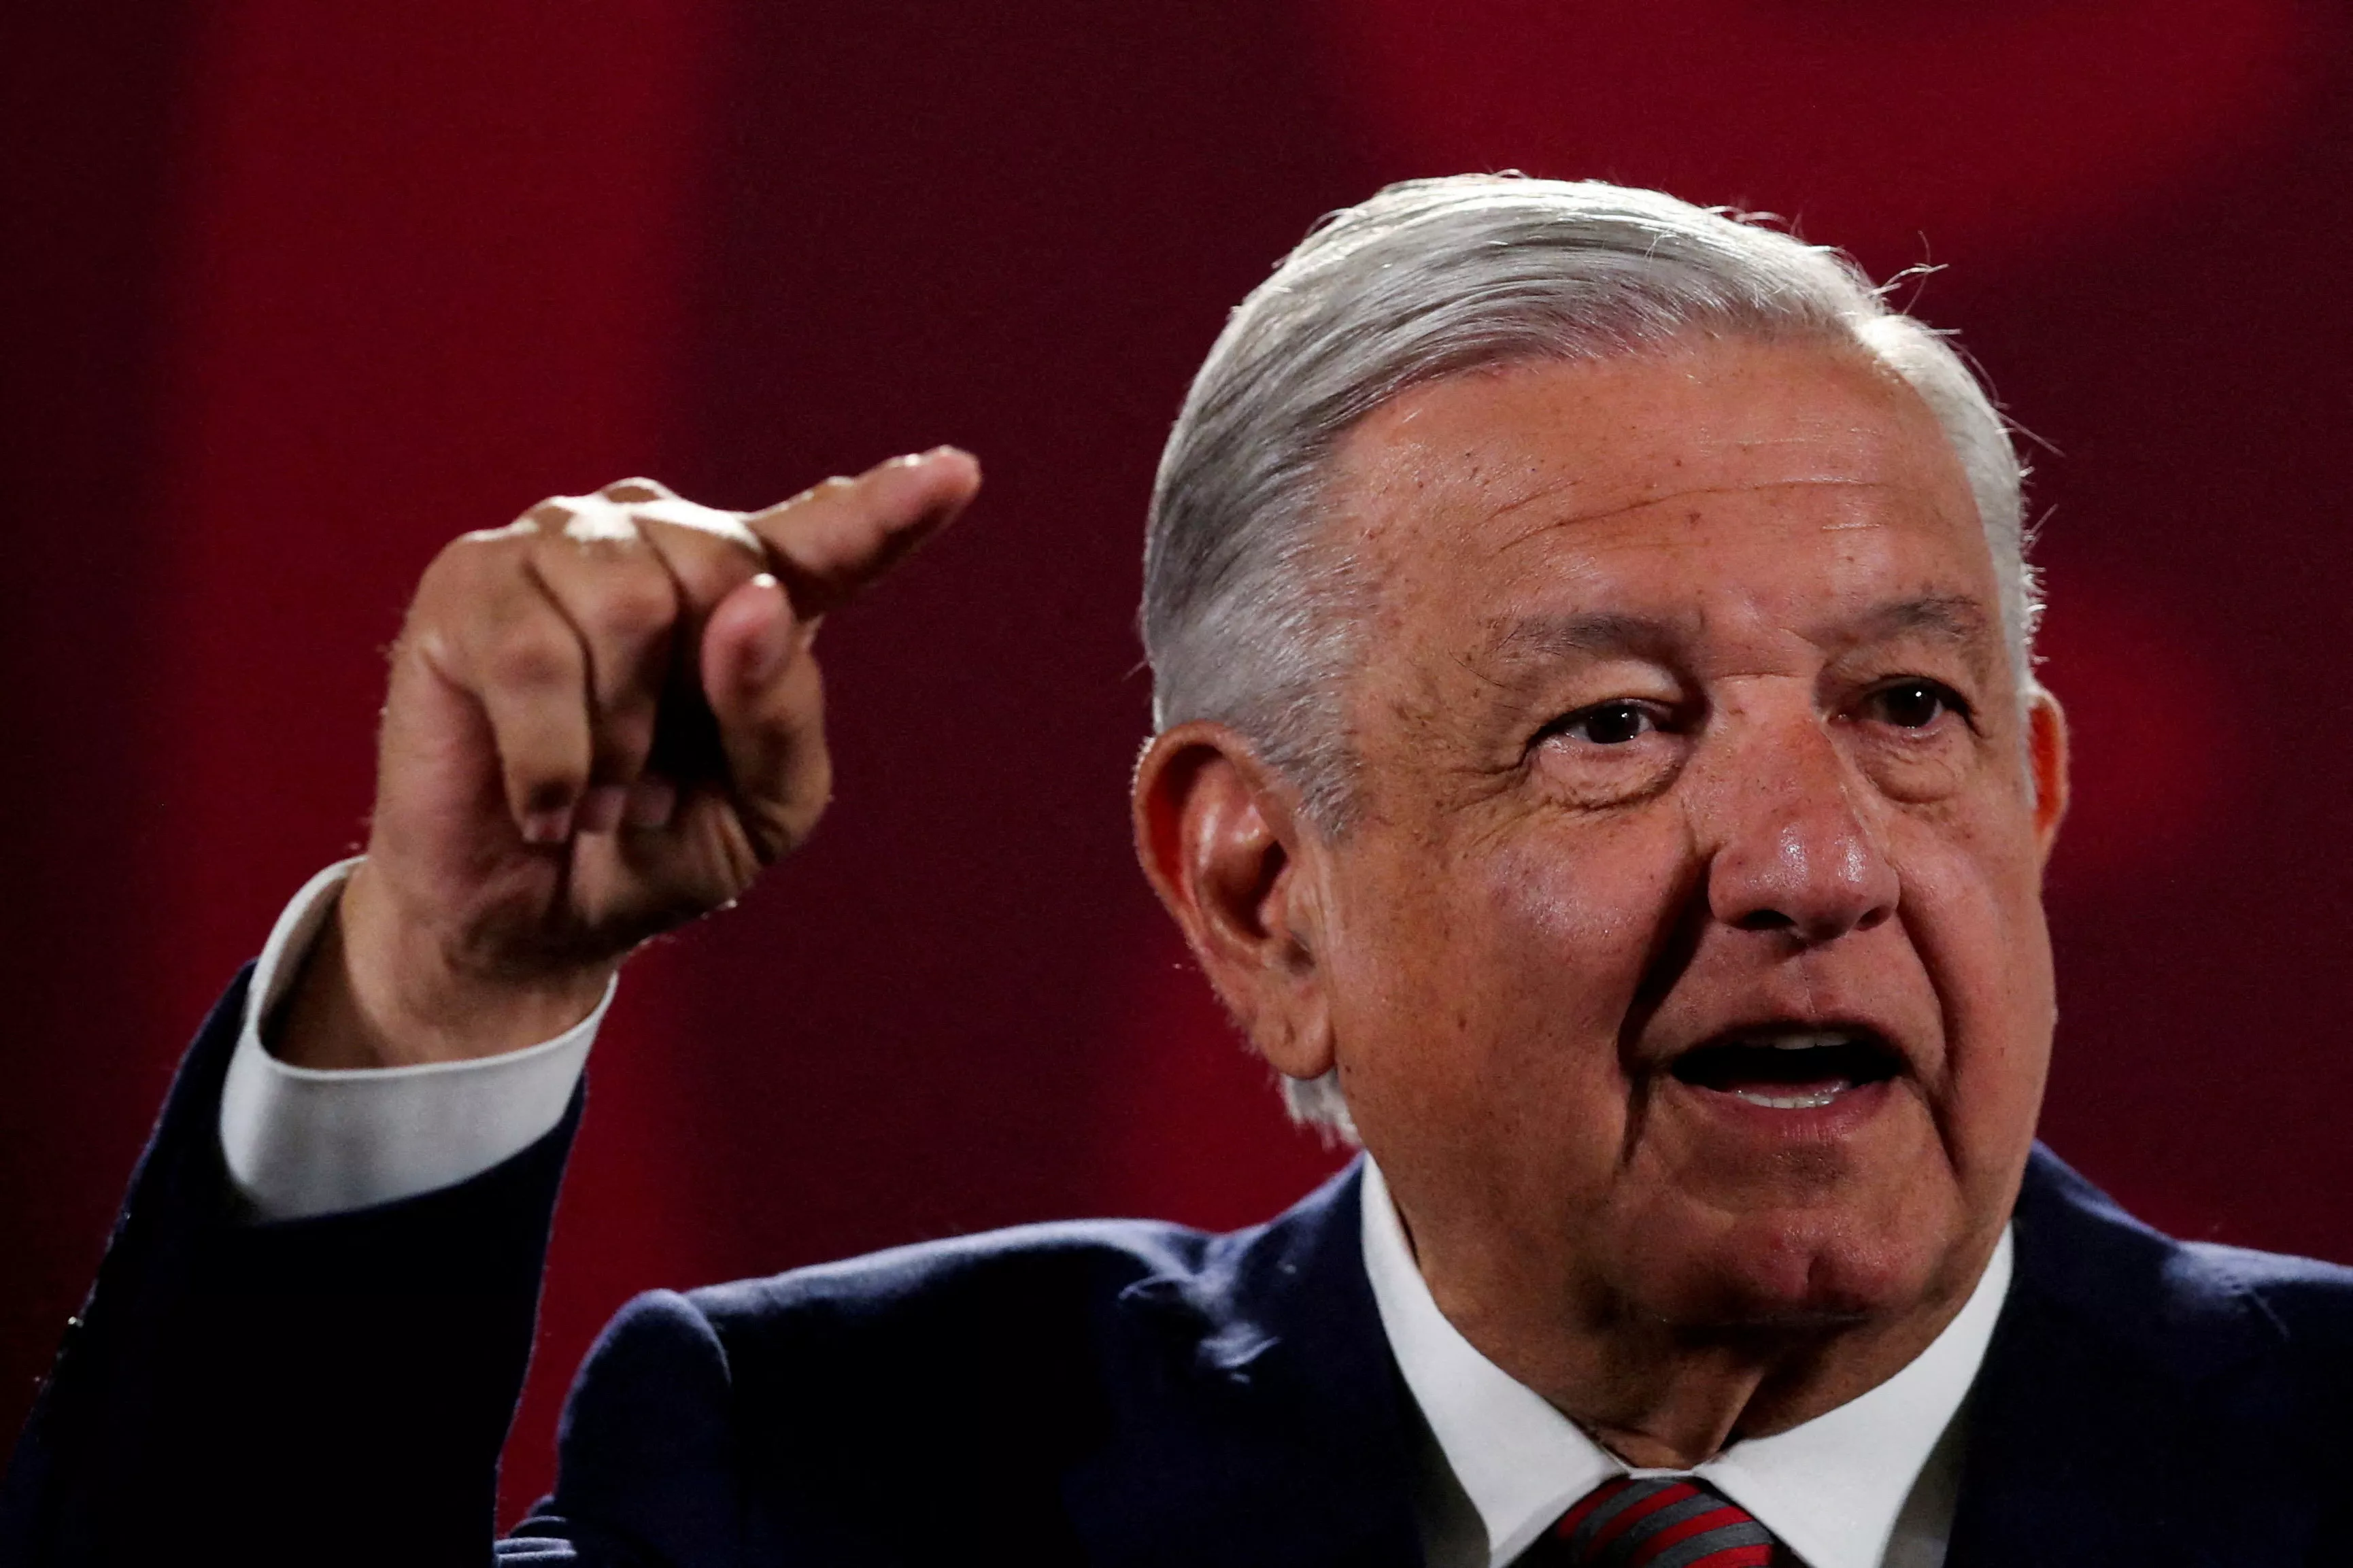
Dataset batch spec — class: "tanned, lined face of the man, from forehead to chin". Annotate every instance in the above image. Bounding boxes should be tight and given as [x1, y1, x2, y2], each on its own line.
[1313, 341, 2063, 1342]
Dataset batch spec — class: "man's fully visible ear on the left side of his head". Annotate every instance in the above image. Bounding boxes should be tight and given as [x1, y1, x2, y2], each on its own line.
[1134, 723, 1332, 1078]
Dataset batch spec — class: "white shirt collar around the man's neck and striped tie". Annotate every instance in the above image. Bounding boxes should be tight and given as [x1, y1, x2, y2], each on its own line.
[1362, 1159, 2012, 1568]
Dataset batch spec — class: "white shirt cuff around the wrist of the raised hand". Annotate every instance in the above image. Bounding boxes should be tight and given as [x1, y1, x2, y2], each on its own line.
[221, 859, 614, 1220]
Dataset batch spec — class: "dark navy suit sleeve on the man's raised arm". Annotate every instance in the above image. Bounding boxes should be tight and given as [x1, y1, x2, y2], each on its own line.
[0, 970, 581, 1566]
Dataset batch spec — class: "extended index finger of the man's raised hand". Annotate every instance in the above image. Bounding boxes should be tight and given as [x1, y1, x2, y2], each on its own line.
[743, 447, 981, 619]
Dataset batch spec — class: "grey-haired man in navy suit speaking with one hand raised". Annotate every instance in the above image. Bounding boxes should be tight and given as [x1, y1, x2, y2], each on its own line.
[7, 179, 2353, 1568]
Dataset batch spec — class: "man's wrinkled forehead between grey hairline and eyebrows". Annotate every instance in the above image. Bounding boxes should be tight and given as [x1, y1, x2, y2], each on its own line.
[1332, 341, 1995, 654]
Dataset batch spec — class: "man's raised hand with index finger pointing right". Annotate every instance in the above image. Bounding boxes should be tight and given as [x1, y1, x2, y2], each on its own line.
[273, 447, 979, 1066]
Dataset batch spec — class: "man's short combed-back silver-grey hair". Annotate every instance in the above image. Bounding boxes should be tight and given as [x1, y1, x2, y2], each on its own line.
[1141, 174, 2040, 1135]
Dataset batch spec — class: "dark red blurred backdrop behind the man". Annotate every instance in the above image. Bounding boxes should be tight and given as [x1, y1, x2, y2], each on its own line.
[0, 0, 2353, 1500]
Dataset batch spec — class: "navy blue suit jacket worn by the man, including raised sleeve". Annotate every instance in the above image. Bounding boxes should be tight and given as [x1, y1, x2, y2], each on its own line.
[0, 960, 2353, 1568]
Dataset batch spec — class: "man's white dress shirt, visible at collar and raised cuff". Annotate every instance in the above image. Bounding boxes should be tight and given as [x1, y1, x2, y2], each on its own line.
[221, 862, 2012, 1568]
